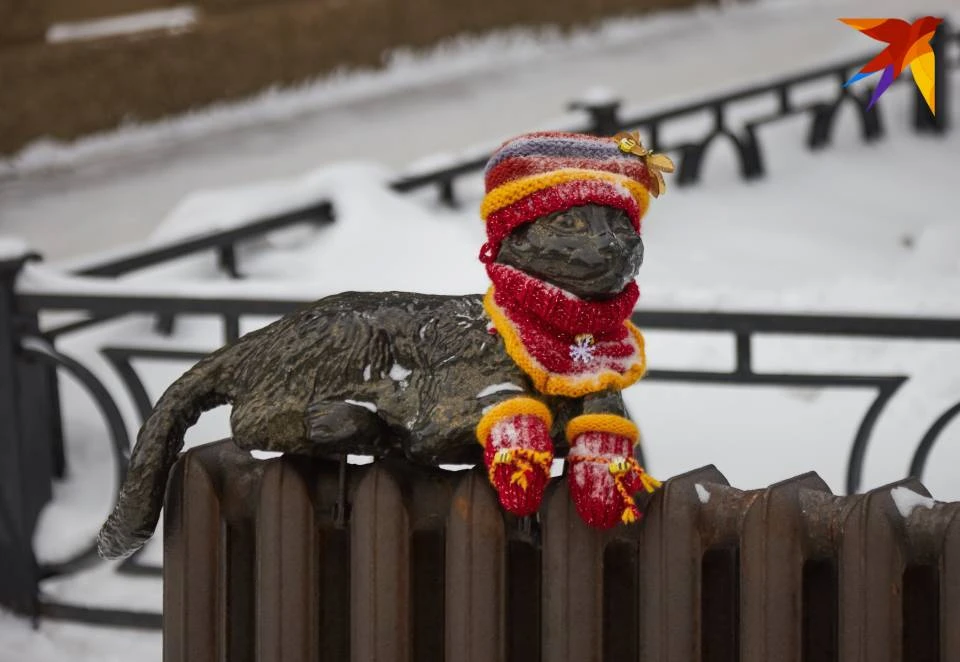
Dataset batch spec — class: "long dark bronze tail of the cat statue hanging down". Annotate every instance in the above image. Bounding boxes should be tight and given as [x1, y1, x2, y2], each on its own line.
[97, 348, 231, 559]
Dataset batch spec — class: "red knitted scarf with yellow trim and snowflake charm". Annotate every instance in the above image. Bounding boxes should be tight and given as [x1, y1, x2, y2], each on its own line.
[483, 263, 646, 398]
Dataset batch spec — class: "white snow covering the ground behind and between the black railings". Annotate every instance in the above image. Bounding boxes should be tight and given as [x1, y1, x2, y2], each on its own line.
[0, 0, 960, 662]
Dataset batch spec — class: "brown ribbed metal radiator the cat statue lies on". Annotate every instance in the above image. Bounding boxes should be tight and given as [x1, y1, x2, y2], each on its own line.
[164, 441, 960, 662]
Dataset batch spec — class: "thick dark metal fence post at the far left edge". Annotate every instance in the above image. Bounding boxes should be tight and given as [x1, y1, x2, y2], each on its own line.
[0, 248, 42, 617]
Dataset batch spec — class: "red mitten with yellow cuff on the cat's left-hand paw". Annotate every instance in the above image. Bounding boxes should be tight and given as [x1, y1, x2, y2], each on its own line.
[477, 397, 553, 517]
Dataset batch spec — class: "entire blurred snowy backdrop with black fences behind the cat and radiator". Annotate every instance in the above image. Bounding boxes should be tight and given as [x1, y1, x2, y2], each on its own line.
[0, 0, 960, 662]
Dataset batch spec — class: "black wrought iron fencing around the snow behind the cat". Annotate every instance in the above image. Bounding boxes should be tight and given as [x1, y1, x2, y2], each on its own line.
[0, 19, 960, 627]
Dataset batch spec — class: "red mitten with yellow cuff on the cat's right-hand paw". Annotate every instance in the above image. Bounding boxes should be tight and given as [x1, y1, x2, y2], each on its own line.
[567, 414, 660, 529]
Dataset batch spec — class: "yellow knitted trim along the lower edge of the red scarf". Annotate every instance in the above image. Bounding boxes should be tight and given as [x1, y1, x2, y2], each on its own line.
[483, 286, 647, 398]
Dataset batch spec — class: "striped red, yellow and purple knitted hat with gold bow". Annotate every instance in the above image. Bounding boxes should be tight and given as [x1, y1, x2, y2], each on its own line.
[480, 131, 673, 262]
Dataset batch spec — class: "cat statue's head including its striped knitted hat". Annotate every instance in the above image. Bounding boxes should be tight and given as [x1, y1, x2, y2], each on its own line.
[480, 132, 673, 299]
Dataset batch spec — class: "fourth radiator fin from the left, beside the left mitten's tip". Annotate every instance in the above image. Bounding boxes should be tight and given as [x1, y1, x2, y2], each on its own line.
[444, 471, 510, 662]
